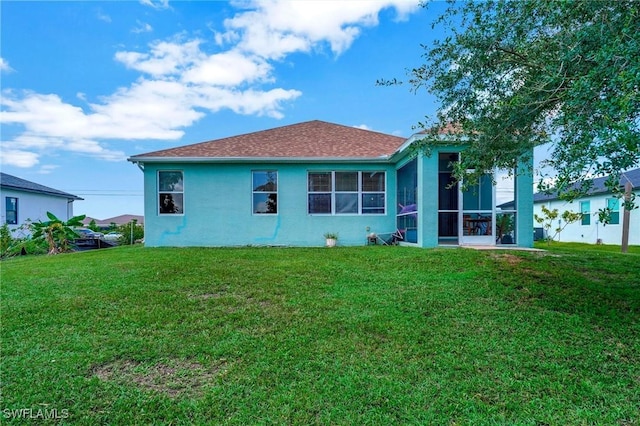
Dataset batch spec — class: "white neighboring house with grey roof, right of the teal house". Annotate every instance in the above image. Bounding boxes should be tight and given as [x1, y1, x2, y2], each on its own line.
[533, 169, 640, 245]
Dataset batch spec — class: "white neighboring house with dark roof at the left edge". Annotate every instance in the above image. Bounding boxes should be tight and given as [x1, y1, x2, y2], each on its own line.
[0, 173, 82, 235]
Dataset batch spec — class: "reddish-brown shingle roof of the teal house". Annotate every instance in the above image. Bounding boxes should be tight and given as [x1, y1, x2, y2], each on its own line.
[129, 120, 405, 162]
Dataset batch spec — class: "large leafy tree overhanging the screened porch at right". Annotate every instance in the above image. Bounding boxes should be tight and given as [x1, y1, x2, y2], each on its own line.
[385, 0, 640, 208]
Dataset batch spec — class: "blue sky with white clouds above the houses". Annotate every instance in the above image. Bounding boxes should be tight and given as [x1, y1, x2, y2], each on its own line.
[0, 0, 536, 219]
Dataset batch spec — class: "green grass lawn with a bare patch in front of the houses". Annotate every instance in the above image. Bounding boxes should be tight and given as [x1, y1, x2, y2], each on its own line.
[0, 245, 640, 426]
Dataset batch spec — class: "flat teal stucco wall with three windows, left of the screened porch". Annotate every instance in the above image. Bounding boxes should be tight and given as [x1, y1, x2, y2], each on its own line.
[144, 163, 396, 247]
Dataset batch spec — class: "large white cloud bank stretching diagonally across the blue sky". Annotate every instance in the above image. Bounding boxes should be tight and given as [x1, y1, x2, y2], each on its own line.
[0, 0, 418, 167]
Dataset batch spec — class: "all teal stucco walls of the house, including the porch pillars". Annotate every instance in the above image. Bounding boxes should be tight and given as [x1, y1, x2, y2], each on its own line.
[144, 145, 533, 247]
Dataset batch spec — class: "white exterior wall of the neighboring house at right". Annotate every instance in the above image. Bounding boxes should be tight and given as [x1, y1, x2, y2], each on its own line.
[534, 191, 640, 245]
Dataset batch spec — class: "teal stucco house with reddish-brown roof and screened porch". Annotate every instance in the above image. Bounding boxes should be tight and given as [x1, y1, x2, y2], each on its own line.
[129, 121, 533, 247]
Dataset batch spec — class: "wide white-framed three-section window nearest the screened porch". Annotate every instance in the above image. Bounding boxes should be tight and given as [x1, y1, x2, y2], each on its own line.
[307, 171, 386, 215]
